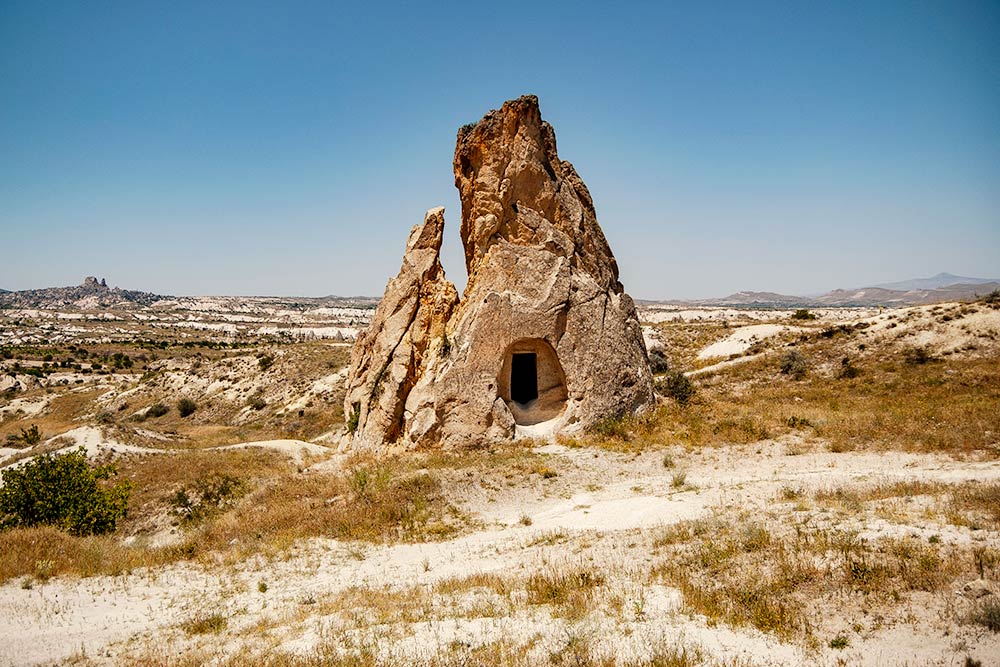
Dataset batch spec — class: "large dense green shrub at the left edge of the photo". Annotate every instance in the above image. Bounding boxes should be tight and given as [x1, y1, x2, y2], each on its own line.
[0, 447, 132, 535]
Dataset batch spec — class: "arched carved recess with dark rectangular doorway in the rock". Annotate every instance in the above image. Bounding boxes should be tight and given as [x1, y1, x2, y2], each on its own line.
[497, 338, 567, 426]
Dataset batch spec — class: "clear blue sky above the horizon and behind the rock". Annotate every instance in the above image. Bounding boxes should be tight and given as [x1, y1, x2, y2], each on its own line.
[0, 0, 1000, 298]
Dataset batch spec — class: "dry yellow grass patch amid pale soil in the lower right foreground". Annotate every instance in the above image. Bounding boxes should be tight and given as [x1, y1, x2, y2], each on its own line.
[653, 518, 973, 640]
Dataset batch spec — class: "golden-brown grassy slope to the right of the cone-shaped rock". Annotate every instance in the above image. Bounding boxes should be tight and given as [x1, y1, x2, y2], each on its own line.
[580, 358, 1000, 458]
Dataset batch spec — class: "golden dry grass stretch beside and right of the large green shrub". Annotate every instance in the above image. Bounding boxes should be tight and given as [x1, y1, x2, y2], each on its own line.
[0, 450, 462, 581]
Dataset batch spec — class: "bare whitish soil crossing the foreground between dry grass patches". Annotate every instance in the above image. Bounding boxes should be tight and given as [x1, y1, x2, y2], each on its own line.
[0, 439, 1000, 665]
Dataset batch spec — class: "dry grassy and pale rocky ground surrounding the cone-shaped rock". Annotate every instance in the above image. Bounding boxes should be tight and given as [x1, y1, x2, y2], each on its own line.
[0, 300, 1000, 666]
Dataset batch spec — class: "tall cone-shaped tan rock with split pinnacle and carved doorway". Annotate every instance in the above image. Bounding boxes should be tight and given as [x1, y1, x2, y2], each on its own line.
[345, 96, 654, 447]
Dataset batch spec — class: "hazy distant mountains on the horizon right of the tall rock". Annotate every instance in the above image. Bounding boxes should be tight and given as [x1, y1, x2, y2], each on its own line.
[640, 273, 1000, 308]
